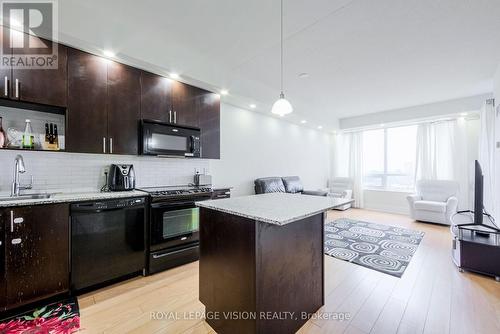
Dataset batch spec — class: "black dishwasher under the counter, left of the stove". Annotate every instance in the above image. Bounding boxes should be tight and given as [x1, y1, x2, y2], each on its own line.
[71, 198, 146, 291]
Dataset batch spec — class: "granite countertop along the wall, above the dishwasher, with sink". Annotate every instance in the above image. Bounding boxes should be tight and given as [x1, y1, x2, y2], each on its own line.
[0, 190, 148, 208]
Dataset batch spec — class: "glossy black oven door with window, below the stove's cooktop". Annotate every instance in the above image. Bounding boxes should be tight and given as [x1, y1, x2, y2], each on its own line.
[150, 201, 200, 251]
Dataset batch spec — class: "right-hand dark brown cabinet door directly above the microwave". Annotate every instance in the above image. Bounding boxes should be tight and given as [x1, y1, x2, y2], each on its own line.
[173, 82, 200, 127]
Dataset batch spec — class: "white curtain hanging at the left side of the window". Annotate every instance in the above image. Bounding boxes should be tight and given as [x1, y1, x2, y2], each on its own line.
[333, 132, 364, 208]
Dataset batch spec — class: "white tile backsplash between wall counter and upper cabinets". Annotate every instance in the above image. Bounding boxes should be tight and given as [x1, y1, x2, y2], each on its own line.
[0, 149, 209, 194]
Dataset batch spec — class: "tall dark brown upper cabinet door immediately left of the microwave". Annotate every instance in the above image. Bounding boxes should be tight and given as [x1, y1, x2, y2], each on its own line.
[106, 61, 141, 154]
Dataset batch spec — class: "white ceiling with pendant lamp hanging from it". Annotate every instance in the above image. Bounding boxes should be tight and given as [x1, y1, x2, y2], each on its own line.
[59, 0, 500, 128]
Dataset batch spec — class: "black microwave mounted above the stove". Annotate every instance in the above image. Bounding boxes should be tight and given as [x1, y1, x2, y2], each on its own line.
[141, 120, 201, 158]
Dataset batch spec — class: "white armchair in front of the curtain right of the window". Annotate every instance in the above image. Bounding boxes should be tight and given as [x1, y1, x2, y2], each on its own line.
[407, 180, 459, 225]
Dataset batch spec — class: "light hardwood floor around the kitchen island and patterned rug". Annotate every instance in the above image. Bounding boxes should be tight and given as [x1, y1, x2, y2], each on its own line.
[79, 209, 500, 334]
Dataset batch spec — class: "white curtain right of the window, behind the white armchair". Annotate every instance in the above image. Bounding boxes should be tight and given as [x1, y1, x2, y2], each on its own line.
[415, 119, 473, 209]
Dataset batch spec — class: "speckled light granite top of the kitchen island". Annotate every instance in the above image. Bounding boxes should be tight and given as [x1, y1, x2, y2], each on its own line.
[196, 193, 352, 225]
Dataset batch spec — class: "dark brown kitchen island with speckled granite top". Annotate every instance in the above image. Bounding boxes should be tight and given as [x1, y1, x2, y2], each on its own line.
[197, 193, 351, 333]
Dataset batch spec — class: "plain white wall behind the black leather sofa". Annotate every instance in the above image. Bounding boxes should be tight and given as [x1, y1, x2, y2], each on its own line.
[210, 104, 330, 196]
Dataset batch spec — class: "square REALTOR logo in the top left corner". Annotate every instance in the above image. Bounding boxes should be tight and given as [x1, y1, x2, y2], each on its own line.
[0, 0, 58, 69]
